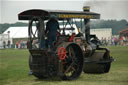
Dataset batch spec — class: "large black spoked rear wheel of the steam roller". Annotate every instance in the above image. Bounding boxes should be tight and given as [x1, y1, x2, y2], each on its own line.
[61, 45, 83, 80]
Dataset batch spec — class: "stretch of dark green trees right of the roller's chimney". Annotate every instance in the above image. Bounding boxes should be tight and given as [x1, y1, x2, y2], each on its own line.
[91, 19, 128, 35]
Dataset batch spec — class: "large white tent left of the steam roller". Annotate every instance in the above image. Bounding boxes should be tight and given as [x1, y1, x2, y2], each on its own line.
[2, 26, 35, 47]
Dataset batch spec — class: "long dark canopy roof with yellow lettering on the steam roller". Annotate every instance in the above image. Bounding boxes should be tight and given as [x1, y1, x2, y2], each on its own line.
[18, 9, 100, 20]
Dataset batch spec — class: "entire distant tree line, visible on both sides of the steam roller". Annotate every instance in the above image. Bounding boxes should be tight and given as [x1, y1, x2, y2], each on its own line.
[0, 19, 128, 35]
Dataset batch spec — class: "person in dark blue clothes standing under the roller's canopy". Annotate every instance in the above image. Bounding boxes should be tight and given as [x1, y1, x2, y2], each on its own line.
[45, 17, 60, 48]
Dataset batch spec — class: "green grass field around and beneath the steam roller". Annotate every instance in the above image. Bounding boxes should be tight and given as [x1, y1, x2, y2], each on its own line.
[0, 46, 128, 85]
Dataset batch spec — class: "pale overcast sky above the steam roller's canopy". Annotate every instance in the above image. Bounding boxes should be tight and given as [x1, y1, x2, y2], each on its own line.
[0, 0, 128, 23]
